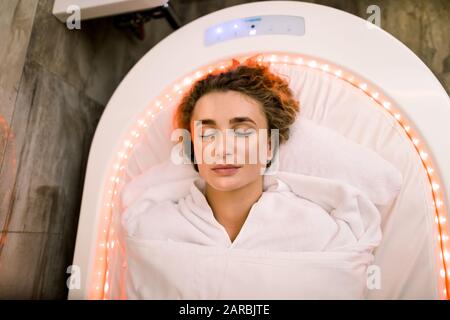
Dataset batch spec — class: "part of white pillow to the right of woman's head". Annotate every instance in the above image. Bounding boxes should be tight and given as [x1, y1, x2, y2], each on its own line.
[279, 115, 402, 206]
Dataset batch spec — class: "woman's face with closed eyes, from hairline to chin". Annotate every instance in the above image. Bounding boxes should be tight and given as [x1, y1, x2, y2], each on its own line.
[191, 90, 271, 191]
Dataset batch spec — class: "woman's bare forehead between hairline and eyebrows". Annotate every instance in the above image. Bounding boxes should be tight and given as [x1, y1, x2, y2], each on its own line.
[191, 90, 266, 126]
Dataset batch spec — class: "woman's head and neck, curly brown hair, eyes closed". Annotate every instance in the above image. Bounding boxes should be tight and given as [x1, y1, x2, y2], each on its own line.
[171, 59, 299, 241]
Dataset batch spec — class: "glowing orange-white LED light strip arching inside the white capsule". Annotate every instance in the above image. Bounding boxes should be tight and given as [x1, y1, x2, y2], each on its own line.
[89, 53, 450, 299]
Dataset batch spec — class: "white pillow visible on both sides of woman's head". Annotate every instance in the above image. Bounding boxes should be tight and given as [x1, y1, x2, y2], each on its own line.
[122, 116, 402, 207]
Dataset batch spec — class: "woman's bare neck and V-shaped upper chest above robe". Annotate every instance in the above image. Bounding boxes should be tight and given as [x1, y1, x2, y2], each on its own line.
[205, 176, 263, 241]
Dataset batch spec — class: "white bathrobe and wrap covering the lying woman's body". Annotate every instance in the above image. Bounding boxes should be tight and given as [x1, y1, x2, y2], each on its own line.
[122, 172, 381, 299]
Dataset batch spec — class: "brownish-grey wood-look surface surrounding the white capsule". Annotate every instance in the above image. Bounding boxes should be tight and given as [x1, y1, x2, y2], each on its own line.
[0, 0, 450, 299]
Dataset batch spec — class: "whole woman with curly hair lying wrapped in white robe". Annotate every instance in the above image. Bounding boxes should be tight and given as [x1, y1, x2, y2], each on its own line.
[122, 59, 381, 299]
